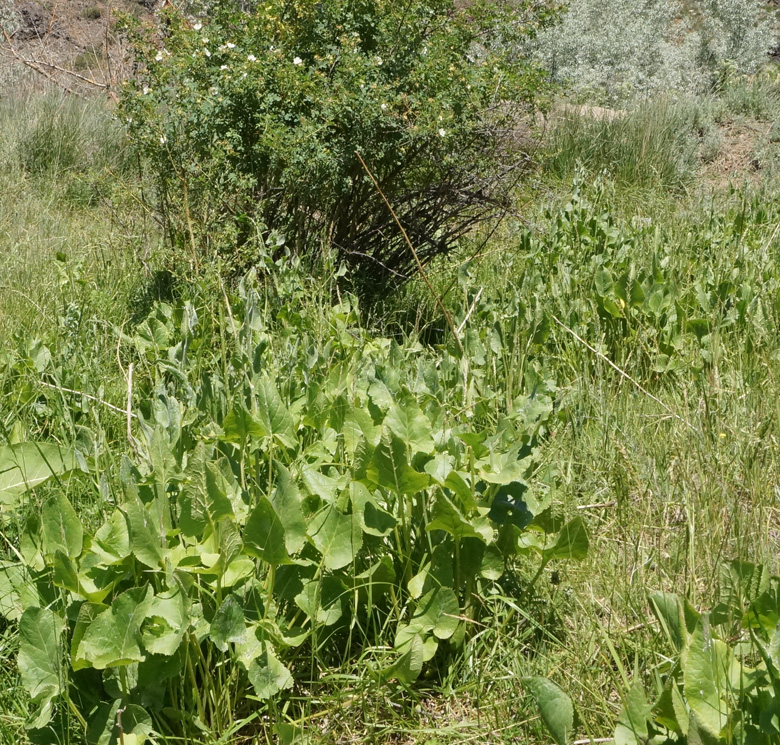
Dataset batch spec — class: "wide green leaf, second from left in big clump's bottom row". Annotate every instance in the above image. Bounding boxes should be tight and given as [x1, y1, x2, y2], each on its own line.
[78, 587, 154, 670]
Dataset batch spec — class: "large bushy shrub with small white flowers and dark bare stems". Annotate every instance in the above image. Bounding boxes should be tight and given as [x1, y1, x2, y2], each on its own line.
[124, 0, 547, 281]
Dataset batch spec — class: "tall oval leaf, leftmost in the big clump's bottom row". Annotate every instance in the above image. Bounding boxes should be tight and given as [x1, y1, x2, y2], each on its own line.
[16, 608, 64, 728]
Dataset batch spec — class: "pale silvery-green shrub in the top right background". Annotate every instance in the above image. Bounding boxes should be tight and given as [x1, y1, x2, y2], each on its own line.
[534, 0, 774, 105]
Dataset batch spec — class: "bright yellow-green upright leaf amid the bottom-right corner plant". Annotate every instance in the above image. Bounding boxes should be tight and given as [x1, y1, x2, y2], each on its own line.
[681, 614, 728, 738]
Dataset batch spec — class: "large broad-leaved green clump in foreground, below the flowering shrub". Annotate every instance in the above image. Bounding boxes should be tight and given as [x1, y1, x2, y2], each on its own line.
[0, 271, 588, 742]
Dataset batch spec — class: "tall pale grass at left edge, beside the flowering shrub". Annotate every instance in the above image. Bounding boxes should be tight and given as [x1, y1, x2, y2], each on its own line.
[0, 92, 154, 341]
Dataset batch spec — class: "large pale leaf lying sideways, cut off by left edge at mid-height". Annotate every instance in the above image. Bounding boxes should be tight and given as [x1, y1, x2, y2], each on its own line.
[0, 442, 78, 512]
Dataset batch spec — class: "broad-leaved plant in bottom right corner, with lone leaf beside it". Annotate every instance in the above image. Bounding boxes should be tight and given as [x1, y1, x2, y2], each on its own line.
[527, 560, 780, 745]
